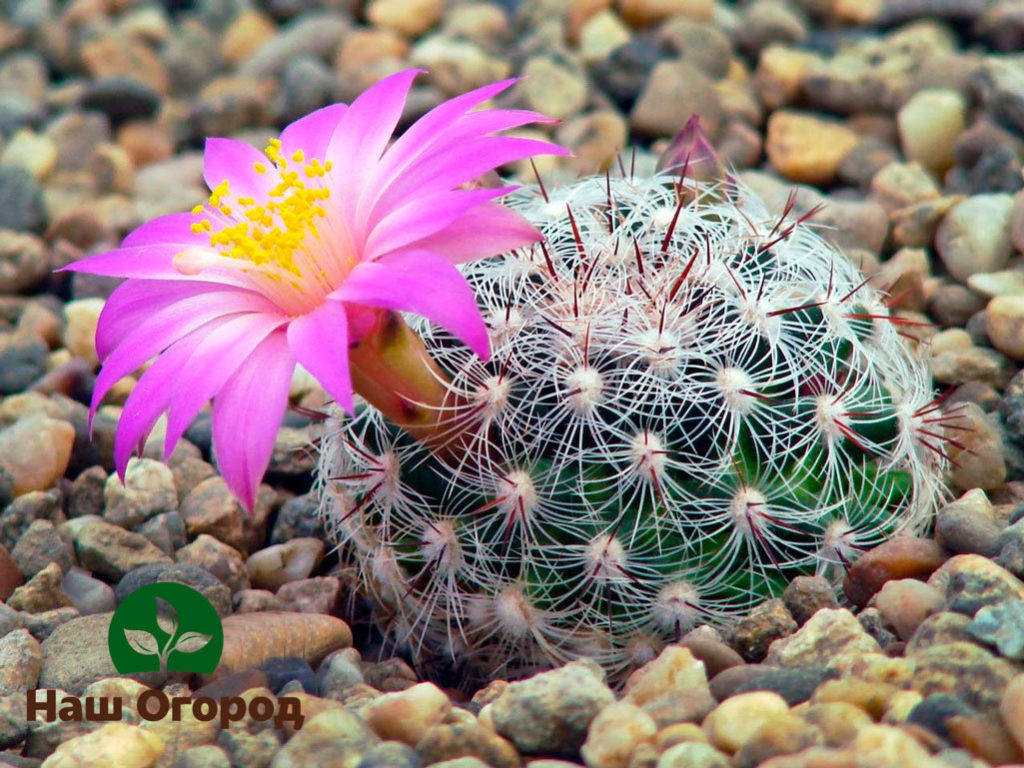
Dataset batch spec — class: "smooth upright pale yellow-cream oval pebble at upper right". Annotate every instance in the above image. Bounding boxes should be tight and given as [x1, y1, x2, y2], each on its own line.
[896, 88, 967, 174]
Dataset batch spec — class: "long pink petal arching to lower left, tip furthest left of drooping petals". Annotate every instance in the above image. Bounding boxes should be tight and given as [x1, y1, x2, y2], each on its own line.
[90, 291, 275, 416]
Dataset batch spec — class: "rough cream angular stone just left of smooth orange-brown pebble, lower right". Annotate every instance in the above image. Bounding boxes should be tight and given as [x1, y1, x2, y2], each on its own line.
[765, 608, 880, 667]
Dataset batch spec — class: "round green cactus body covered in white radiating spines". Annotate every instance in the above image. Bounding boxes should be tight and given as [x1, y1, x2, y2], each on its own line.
[318, 162, 955, 674]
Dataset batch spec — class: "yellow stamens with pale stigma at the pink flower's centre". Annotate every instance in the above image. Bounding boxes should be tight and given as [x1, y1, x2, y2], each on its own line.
[182, 138, 338, 310]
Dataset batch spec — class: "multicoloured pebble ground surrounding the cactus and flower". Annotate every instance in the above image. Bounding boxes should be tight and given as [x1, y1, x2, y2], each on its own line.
[0, 0, 1024, 768]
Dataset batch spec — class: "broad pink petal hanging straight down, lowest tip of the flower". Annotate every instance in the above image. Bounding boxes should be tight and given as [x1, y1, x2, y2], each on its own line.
[212, 331, 295, 512]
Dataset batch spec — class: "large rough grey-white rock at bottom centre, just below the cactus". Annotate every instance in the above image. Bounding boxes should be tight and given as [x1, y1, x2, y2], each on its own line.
[490, 662, 614, 755]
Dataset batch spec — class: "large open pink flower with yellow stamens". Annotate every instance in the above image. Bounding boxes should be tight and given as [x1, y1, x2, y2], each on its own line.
[69, 71, 565, 510]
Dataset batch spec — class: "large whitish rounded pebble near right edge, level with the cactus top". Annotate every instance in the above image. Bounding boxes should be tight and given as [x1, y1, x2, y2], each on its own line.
[935, 194, 1013, 283]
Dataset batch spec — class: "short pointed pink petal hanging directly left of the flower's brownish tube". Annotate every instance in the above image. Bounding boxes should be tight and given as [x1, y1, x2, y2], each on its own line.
[288, 301, 352, 413]
